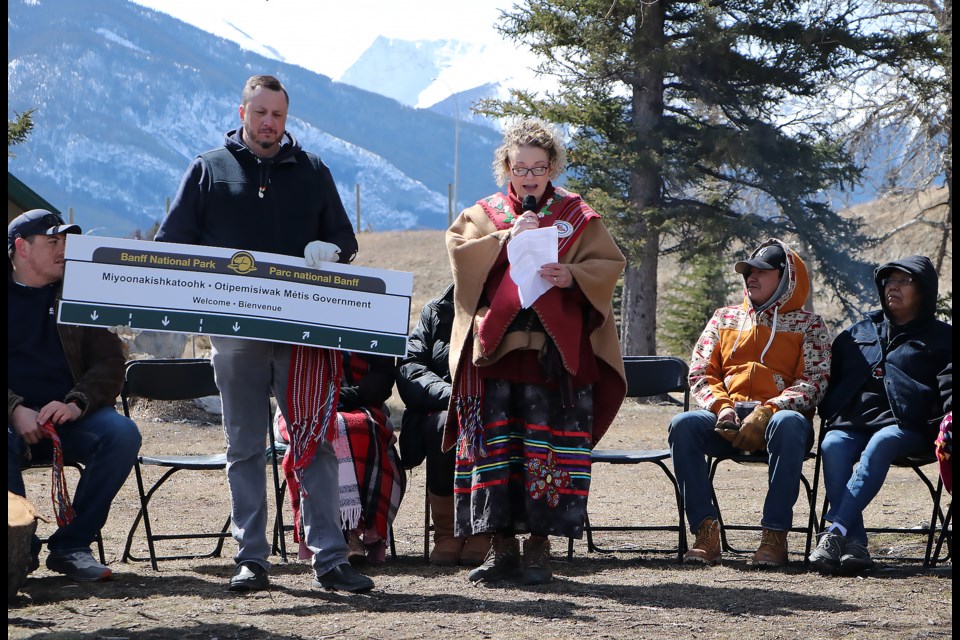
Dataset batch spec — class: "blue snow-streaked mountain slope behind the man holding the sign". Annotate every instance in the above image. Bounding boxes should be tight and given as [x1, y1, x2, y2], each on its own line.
[7, 0, 499, 235]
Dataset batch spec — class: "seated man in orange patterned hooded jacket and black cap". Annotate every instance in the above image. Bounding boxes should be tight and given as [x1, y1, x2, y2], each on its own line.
[668, 239, 830, 567]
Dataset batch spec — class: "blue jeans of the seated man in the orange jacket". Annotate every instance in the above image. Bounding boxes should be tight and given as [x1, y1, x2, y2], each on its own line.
[667, 410, 813, 533]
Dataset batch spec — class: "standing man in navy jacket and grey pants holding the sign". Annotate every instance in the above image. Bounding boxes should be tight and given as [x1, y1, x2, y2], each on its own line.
[156, 76, 373, 592]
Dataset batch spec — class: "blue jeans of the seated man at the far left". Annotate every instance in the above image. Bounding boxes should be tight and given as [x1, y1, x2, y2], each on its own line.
[7, 407, 140, 553]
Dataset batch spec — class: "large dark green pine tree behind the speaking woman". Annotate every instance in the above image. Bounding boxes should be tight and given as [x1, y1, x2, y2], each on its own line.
[480, 0, 924, 354]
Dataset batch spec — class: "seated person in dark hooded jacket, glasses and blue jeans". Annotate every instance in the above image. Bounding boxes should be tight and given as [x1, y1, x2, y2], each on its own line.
[810, 256, 953, 573]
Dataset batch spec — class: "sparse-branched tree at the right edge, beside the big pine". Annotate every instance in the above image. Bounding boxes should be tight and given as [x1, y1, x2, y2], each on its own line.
[825, 0, 953, 271]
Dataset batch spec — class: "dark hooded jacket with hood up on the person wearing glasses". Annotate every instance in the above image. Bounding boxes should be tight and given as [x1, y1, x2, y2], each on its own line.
[820, 256, 953, 446]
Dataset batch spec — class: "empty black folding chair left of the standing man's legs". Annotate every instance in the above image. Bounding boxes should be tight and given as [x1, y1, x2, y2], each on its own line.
[120, 358, 287, 571]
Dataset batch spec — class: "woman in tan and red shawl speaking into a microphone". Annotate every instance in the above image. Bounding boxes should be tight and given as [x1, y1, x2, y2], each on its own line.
[443, 118, 626, 585]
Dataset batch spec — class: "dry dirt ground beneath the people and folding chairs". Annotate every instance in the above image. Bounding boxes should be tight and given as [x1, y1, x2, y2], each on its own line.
[7, 396, 953, 640]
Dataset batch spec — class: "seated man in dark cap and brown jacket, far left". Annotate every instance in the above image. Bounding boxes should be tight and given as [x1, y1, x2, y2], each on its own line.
[7, 209, 140, 582]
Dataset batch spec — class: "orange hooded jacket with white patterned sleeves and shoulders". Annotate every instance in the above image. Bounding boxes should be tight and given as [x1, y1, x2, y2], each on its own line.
[689, 238, 831, 418]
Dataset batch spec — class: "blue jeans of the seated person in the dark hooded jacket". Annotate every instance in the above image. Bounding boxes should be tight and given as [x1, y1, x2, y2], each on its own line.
[820, 425, 933, 546]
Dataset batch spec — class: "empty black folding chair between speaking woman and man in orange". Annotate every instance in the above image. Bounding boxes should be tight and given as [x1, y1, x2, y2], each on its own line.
[567, 356, 690, 562]
